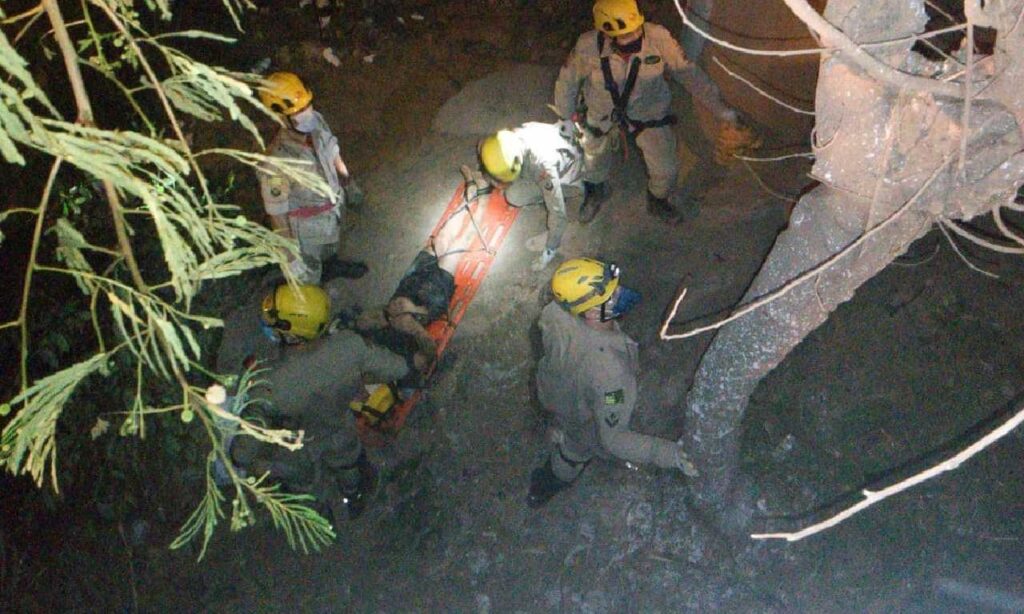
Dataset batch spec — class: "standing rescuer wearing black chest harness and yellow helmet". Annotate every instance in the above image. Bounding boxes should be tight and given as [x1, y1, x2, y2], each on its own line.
[555, 0, 736, 221]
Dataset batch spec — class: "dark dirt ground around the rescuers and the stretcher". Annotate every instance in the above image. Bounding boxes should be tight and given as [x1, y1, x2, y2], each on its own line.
[12, 2, 1024, 613]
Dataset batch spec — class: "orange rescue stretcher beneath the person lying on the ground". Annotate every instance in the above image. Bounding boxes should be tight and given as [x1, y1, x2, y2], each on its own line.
[350, 181, 519, 447]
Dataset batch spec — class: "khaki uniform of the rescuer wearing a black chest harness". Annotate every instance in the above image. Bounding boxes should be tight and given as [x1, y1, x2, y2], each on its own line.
[555, 23, 732, 199]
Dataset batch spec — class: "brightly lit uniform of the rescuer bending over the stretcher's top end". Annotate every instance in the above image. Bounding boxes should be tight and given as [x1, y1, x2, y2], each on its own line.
[505, 122, 583, 251]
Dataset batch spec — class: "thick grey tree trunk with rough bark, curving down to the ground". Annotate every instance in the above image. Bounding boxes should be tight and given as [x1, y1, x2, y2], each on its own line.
[685, 0, 1024, 511]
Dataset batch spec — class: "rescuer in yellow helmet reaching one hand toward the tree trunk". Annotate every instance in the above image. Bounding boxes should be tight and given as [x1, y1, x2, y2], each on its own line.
[526, 258, 694, 508]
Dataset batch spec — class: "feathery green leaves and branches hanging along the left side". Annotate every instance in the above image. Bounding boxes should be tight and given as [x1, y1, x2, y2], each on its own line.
[0, 0, 334, 558]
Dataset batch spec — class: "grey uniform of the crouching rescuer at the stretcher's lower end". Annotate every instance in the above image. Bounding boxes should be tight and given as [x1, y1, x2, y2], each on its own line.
[232, 331, 408, 493]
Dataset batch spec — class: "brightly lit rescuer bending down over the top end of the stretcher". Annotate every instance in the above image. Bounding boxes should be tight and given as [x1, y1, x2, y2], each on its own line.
[478, 122, 583, 271]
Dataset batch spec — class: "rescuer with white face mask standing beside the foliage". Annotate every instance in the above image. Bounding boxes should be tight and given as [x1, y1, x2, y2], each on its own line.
[258, 73, 367, 283]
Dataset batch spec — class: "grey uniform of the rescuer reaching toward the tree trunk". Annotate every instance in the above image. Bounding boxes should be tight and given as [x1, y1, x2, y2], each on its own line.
[537, 302, 679, 482]
